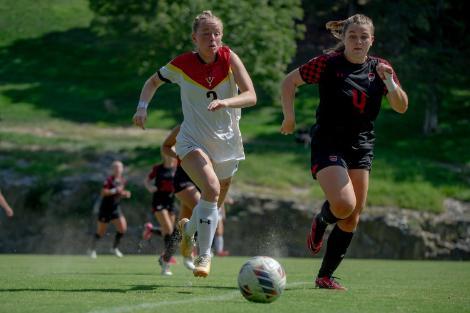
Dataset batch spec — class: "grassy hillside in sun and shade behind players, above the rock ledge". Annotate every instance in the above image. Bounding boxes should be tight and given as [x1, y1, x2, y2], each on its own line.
[0, 0, 470, 212]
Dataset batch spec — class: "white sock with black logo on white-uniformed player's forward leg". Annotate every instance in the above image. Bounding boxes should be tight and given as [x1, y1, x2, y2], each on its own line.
[191, 200, 219, 255]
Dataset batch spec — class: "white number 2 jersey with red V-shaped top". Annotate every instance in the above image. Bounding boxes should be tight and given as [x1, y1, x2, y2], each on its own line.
[159, 46, 245, 163]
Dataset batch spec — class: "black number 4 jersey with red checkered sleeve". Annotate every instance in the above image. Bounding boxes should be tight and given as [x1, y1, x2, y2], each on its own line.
[299, 53, 398, 148]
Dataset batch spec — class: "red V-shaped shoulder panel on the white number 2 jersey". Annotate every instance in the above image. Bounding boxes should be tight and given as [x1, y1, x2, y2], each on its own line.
[170, 46, 230, 90]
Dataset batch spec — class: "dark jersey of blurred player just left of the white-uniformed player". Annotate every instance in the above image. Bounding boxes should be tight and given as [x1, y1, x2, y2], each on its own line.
[148, 163, 175, 205]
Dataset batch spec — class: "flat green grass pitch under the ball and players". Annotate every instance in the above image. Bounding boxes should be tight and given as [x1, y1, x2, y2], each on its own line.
[0, 255, 470, 313]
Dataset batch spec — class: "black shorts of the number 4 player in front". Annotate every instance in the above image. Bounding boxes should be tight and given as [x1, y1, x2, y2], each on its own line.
[310, 140, 374, 179]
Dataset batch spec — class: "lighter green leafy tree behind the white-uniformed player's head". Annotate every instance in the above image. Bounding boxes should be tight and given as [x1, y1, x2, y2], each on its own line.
[90, 0, 304, 98]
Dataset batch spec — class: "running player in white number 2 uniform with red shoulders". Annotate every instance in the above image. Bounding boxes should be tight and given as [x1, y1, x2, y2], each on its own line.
[133, 11, 256, 277]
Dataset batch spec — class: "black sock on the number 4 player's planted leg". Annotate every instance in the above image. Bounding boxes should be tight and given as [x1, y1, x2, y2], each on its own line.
[318, 225, 354, 277]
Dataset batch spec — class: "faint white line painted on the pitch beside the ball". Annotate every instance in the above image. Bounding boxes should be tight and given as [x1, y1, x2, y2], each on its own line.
[88, 282, 312, 313]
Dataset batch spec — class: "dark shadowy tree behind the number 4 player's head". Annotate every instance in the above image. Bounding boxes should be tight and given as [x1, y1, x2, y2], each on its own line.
[299, 0, 470, 135]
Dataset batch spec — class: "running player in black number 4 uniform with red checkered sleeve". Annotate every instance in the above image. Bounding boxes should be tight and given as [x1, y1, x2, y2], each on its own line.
[281, 14, 408, 290]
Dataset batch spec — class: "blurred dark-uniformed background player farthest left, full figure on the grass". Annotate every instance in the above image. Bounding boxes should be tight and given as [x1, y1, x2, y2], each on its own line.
[90, 161, 131, 259]
